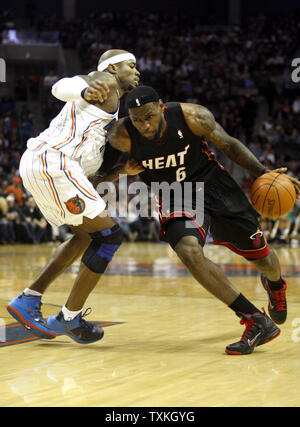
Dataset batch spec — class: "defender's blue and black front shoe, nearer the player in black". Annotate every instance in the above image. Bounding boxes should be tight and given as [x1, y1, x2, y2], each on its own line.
[47, 309, 104, 344]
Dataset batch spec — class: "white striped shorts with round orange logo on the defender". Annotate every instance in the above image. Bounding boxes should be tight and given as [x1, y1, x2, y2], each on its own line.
[19, 149, 106, 226]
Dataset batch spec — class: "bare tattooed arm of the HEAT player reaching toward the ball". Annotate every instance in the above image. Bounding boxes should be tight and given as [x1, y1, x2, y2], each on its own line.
[181, 104, 270, 177]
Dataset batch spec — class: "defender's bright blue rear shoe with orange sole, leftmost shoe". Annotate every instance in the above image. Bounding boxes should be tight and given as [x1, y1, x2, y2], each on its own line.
[6, 293, 56, 340]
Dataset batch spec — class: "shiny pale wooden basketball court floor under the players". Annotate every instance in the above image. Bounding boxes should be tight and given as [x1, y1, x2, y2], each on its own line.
[0, 243, 300, 407]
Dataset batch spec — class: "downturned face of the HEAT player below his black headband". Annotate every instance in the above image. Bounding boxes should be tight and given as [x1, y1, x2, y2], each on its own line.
[129, 101, 166, 141]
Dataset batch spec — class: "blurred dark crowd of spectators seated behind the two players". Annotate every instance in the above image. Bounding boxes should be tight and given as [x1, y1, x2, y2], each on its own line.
[0, 11, 300, 244]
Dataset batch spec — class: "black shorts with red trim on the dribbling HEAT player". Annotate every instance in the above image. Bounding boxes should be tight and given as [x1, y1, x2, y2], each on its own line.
[161, 170, 270, 259]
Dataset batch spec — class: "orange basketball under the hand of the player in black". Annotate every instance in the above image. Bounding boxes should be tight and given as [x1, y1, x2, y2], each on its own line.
[250, 172, 296, 219]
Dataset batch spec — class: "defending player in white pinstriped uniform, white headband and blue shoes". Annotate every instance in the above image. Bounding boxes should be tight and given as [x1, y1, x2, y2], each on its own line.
[7, 50, 140, 344]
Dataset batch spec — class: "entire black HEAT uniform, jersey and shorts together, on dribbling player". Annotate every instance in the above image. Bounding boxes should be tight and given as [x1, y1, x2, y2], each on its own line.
[125, 102, 269, 259]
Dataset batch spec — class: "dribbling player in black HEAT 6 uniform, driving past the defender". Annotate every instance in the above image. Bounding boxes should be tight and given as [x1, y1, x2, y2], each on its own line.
[106, 86, 300, 354]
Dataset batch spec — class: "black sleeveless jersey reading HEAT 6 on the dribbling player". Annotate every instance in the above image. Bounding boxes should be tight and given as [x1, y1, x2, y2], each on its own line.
[125, 102, 221, 184]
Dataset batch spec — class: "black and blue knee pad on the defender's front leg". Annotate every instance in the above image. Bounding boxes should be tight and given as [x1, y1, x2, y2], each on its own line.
[82, 225, 123, 274]
